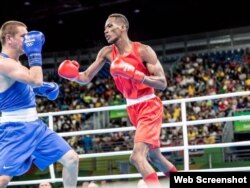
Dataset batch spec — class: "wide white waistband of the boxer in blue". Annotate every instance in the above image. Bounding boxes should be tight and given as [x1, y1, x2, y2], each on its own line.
[1, 108, 38, 123]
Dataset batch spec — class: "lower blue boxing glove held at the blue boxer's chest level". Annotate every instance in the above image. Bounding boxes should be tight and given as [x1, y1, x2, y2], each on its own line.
[33, 82, 59, 101]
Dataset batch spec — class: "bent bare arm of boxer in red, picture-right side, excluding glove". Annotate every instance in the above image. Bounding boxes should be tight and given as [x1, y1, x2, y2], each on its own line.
[139, 45, 167, 90]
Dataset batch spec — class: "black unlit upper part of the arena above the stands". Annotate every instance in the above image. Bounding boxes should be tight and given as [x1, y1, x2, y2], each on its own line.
[0, 0, 250, 51]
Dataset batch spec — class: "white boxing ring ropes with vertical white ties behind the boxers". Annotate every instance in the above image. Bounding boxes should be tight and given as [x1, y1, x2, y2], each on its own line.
[4, 91, 250, 186]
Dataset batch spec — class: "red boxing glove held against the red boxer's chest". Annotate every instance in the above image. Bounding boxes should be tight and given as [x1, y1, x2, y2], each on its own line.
[110, 58, 145, 82]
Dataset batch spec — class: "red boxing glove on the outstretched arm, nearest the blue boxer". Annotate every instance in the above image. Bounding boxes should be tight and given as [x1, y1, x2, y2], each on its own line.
[58, 60, 80, 81]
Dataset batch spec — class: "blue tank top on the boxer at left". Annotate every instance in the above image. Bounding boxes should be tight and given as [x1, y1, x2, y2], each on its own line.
[0, 53, 36, 112]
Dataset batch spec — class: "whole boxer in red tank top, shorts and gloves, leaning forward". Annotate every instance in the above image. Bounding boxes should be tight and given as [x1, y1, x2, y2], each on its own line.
[58, 14, 176, 188]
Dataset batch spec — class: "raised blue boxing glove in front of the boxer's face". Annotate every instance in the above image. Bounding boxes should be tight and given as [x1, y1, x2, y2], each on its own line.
[23, 31, 45, 67]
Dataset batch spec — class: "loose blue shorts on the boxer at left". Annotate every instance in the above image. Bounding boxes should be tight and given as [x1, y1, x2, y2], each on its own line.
[0, 119, 71, 176]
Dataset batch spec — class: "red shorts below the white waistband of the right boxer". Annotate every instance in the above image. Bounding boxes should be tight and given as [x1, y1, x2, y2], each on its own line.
[127, 97, 163, 149]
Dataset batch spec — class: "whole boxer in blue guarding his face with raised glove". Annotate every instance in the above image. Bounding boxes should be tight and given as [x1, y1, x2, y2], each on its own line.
[0, 21, 79, 188]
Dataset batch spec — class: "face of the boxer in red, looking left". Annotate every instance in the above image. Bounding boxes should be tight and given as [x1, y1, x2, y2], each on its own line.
[104, 17, 124, 44]
